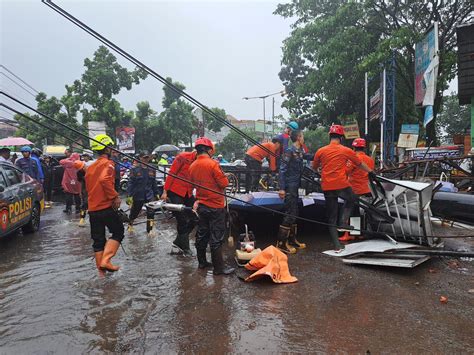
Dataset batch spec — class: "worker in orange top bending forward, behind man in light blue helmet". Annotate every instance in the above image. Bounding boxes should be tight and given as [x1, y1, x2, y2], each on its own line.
[245, 136, 282, 191]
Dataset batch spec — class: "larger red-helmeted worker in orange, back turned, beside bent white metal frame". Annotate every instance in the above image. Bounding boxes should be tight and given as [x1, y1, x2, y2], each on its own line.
[313, 125, 373, 252]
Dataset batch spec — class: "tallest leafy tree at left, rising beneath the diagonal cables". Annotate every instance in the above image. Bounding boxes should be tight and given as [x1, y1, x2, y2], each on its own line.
[72, 46, 147, 134]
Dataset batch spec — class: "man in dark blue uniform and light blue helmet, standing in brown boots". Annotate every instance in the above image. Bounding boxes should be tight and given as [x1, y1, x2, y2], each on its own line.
[277, 130, 313, 254]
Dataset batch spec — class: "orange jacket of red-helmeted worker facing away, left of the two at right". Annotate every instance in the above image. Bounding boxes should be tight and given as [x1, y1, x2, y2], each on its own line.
[313, 141, 362, 191]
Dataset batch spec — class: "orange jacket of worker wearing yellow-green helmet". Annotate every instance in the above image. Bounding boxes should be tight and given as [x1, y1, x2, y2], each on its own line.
[86, 157, 118, 211]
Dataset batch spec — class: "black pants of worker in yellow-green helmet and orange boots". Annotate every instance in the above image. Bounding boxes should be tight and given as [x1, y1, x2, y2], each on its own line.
[89, 207, 124, 252]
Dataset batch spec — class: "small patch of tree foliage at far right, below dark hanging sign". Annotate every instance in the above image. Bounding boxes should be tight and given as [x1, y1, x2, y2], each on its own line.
[436, 94, 471, 141]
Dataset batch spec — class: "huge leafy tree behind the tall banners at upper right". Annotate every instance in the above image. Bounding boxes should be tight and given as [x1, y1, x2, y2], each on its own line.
[275, 0, 473, 143]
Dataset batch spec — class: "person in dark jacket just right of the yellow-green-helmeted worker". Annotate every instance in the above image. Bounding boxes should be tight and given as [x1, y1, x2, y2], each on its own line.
[127, 152, 160, 237]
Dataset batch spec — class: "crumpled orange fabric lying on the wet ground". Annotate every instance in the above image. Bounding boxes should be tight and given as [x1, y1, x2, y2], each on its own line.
[245, 245, 298, 283]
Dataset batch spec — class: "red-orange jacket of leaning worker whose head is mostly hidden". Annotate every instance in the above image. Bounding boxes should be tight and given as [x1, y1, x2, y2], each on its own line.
[164, 152, 196, 197]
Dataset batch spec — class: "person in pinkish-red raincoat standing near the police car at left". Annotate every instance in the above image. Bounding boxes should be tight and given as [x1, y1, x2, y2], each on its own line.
[59, 153, 81, 214]
